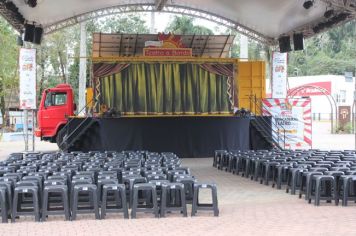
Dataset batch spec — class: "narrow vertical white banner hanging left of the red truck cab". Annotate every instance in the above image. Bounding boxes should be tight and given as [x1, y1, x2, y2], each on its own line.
[19, 48, 36, 109]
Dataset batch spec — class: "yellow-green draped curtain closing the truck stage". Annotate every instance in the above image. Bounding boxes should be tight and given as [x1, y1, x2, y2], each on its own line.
[100, 63, 230, 114]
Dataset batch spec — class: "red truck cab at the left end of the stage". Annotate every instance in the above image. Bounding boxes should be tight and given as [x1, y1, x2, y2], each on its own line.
[35, 84, 76, 142]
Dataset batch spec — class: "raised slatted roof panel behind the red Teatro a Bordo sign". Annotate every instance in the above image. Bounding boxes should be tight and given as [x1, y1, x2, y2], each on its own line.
[93, 33, 235, 58]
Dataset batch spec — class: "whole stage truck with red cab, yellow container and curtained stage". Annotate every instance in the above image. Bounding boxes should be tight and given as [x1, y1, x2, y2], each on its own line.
[36, 33, 268, 157]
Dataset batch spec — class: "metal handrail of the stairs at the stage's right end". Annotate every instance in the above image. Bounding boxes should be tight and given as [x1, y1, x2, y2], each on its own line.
[249, 95, 286, 149]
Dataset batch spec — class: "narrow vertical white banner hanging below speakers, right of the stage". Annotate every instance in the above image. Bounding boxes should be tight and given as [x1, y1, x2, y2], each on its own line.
[272, 52, 288, 98]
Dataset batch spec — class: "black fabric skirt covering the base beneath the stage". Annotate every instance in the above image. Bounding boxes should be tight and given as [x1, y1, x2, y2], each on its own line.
[68, 116, 268, 158]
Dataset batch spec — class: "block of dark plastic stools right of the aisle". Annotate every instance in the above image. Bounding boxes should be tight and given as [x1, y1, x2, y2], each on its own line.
[213, 149, 356, 206]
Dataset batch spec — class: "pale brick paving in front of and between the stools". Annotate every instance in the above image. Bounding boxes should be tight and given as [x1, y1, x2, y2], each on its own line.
[0, 158, 356, 236]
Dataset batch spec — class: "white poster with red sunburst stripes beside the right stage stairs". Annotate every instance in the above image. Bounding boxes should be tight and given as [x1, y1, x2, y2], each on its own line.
[262, 98, 312, 149]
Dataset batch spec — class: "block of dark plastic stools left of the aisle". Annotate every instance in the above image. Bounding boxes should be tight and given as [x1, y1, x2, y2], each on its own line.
[0, 151, 218, 222]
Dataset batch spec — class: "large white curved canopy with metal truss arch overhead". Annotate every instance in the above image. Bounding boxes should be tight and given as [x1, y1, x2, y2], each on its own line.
[0, 0, 356, 45]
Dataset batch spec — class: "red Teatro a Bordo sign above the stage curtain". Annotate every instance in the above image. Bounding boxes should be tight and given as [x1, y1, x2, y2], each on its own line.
[143, 48, 192, 57]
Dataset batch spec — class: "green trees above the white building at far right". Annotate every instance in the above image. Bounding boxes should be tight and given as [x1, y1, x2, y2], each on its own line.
[288, 21, 356, 76]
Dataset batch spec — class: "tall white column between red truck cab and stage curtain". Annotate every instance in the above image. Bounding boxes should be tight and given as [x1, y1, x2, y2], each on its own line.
[77, 22, 87, 115]
